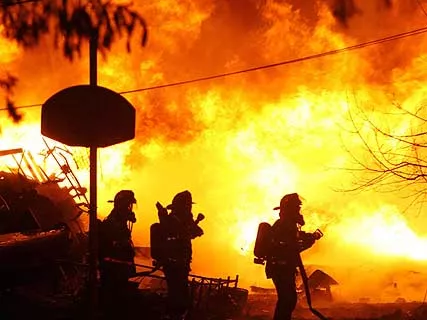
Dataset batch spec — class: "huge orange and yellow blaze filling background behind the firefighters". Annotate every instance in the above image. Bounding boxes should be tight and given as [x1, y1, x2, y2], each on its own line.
[0, 0, 427, 299]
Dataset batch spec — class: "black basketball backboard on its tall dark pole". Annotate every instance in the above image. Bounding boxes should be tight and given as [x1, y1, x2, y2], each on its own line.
[41, 62, 135, 319]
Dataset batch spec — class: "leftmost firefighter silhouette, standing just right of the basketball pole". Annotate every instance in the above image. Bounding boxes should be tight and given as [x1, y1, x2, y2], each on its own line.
[98, 190, 136, 316]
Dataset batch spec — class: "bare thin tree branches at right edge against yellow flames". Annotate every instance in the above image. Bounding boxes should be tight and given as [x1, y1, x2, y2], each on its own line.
[348, 103, 427, 208]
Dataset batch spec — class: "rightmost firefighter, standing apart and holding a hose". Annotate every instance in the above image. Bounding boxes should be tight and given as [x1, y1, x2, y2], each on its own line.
[254, 193, 322, 320]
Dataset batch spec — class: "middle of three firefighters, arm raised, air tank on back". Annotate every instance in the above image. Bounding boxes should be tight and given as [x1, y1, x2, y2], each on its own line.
[150, 190, 204, 319]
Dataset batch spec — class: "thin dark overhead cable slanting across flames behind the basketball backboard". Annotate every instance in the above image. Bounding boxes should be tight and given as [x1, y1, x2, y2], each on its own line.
[0, 27, 427, 111]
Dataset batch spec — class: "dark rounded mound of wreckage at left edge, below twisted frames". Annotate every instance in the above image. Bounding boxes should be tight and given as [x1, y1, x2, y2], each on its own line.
[0, 171, 82, 292]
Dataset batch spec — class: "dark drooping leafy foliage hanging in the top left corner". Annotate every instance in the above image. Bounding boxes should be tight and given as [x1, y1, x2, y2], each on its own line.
[0, 0, 147, 122]
